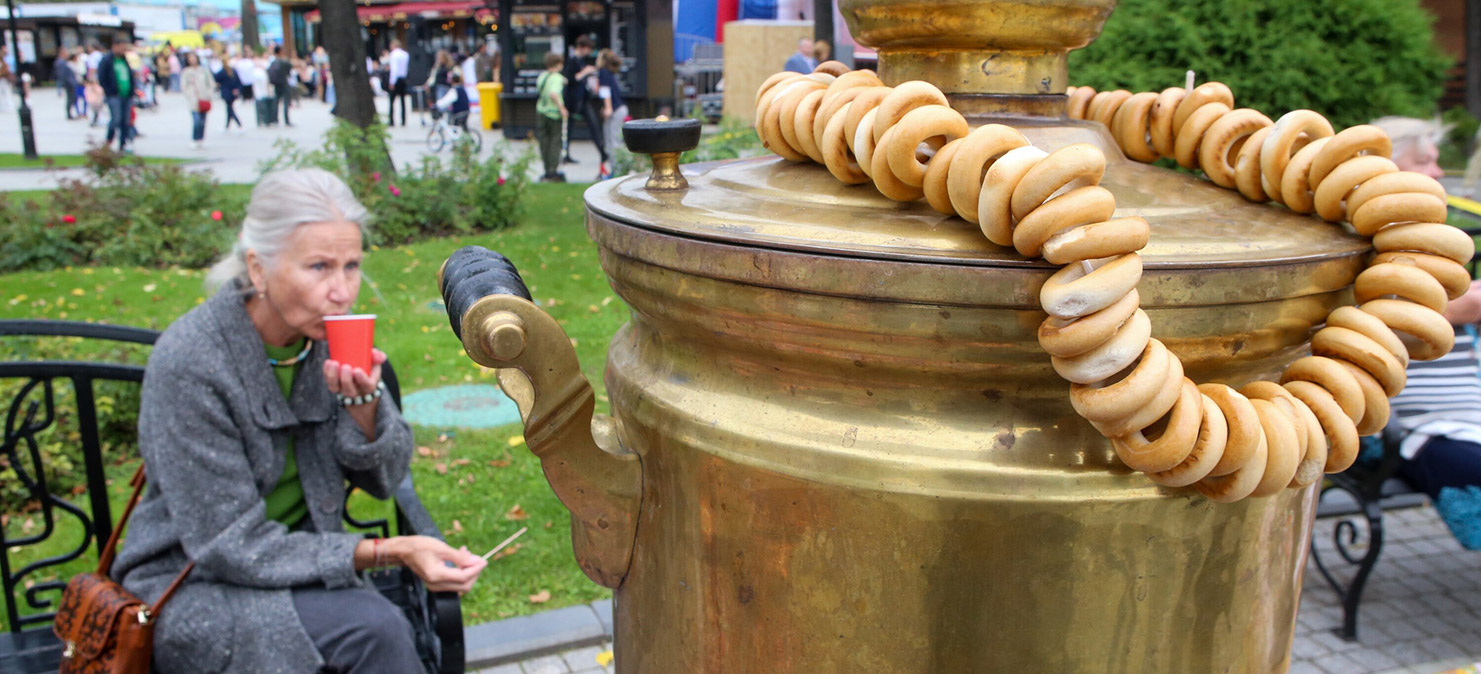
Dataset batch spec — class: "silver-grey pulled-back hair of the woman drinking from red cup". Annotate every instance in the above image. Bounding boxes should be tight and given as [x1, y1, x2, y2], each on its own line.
[206, 169, 370, 292]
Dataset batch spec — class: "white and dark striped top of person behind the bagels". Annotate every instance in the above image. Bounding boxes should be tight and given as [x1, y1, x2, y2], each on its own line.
[1392, 326, 1481, 459]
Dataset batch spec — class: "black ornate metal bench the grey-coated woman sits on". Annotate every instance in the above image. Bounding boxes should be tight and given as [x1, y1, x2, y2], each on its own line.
[0, 320, 465, 674]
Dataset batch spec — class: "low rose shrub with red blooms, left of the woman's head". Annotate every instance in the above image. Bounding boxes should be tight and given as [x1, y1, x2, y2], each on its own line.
[0, 148, 244, 273]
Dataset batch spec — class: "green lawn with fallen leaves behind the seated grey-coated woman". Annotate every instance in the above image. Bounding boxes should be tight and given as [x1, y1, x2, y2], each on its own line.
[0, 185, 628, 630]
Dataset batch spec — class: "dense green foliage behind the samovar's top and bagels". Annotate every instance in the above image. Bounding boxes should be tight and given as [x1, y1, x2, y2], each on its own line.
[1069, 0, 1453, 127]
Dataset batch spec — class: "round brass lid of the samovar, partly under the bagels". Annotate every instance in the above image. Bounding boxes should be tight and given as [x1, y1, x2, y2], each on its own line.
[586, 120, 1368, 271]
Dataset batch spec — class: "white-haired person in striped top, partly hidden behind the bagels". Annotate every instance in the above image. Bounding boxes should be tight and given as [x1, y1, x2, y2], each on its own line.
[1374, 117, 1481, 550]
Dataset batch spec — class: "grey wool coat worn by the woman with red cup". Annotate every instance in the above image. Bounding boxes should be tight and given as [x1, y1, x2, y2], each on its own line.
[113, 284, 412, 674]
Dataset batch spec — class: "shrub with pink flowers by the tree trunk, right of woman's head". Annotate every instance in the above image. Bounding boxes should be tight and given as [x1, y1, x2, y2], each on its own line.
[258, 121, 535, 246]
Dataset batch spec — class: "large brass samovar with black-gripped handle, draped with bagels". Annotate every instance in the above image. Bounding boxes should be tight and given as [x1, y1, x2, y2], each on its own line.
[441, 0, 1350, 674]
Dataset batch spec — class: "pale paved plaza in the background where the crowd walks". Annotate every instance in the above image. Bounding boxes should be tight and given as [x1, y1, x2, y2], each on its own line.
[0, 87, 610, 191]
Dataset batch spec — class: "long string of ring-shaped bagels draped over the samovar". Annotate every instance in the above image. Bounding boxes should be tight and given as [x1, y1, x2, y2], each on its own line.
[755, 62, 1474, 502]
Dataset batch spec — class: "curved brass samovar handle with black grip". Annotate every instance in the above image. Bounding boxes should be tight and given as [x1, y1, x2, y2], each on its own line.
[437, 246, 643, 588]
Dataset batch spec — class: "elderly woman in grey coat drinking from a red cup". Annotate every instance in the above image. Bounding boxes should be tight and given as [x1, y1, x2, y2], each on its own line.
[113, 170, 486, 674]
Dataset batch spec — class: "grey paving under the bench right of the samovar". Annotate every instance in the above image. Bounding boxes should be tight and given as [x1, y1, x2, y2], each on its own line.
[1290, 505, 1481, 674]
